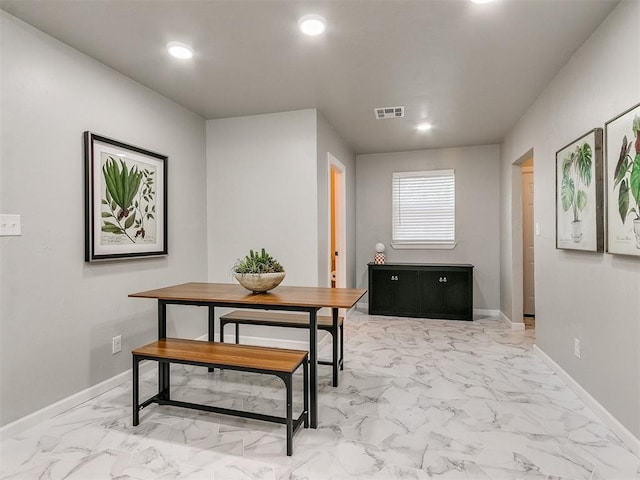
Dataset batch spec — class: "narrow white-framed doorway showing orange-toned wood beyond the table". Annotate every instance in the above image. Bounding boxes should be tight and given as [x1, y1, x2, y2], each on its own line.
[327, 153, 347, 288]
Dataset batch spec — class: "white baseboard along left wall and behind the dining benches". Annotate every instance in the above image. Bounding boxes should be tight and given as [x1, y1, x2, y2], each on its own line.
[0, 335, 331, 441]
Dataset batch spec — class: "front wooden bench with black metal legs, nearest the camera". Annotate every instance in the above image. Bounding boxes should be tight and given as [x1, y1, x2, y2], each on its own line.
[131, 338, 309, 455]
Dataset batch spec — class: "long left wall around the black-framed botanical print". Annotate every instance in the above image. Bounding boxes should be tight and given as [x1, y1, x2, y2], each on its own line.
[0, 11, 207, 425]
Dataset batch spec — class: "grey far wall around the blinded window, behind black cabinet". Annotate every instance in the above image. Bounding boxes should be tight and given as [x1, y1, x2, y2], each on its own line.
[356, 145, 500, 310]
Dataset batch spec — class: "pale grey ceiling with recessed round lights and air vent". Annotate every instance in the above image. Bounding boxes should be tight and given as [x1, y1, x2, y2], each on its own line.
[0, 0, 619, 153]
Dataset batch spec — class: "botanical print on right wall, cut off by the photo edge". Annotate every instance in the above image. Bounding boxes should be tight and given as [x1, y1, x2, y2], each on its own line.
[605, 104, 640, 256]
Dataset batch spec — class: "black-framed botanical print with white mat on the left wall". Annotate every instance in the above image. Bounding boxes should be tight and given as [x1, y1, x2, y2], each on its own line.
[85, 132, 167, 261]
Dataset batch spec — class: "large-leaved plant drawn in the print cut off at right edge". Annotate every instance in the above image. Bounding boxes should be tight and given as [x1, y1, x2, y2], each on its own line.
[613, 115, 640, 248]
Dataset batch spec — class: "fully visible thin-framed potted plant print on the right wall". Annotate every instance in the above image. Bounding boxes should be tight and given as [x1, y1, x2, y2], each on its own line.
[556, 128, 604, 252]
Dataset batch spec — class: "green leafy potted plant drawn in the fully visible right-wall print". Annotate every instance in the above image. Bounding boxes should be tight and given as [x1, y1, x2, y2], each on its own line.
[560, 143, 593, 243]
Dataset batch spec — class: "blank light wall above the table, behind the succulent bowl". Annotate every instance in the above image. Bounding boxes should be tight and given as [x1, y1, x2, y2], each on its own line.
[207, 109, 318, 286]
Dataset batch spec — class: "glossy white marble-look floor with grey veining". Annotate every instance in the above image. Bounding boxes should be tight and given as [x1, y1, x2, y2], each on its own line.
[0, 312, 640, 480]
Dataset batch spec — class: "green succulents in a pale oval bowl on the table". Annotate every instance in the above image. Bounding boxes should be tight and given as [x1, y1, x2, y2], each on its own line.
[233, 248, 285, 293]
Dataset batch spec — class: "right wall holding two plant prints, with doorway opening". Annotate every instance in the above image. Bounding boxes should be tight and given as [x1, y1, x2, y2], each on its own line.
[501, 0, 640, 438]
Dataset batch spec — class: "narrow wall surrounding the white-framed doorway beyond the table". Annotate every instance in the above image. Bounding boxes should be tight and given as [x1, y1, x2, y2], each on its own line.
[317, 112, 356, 288]
